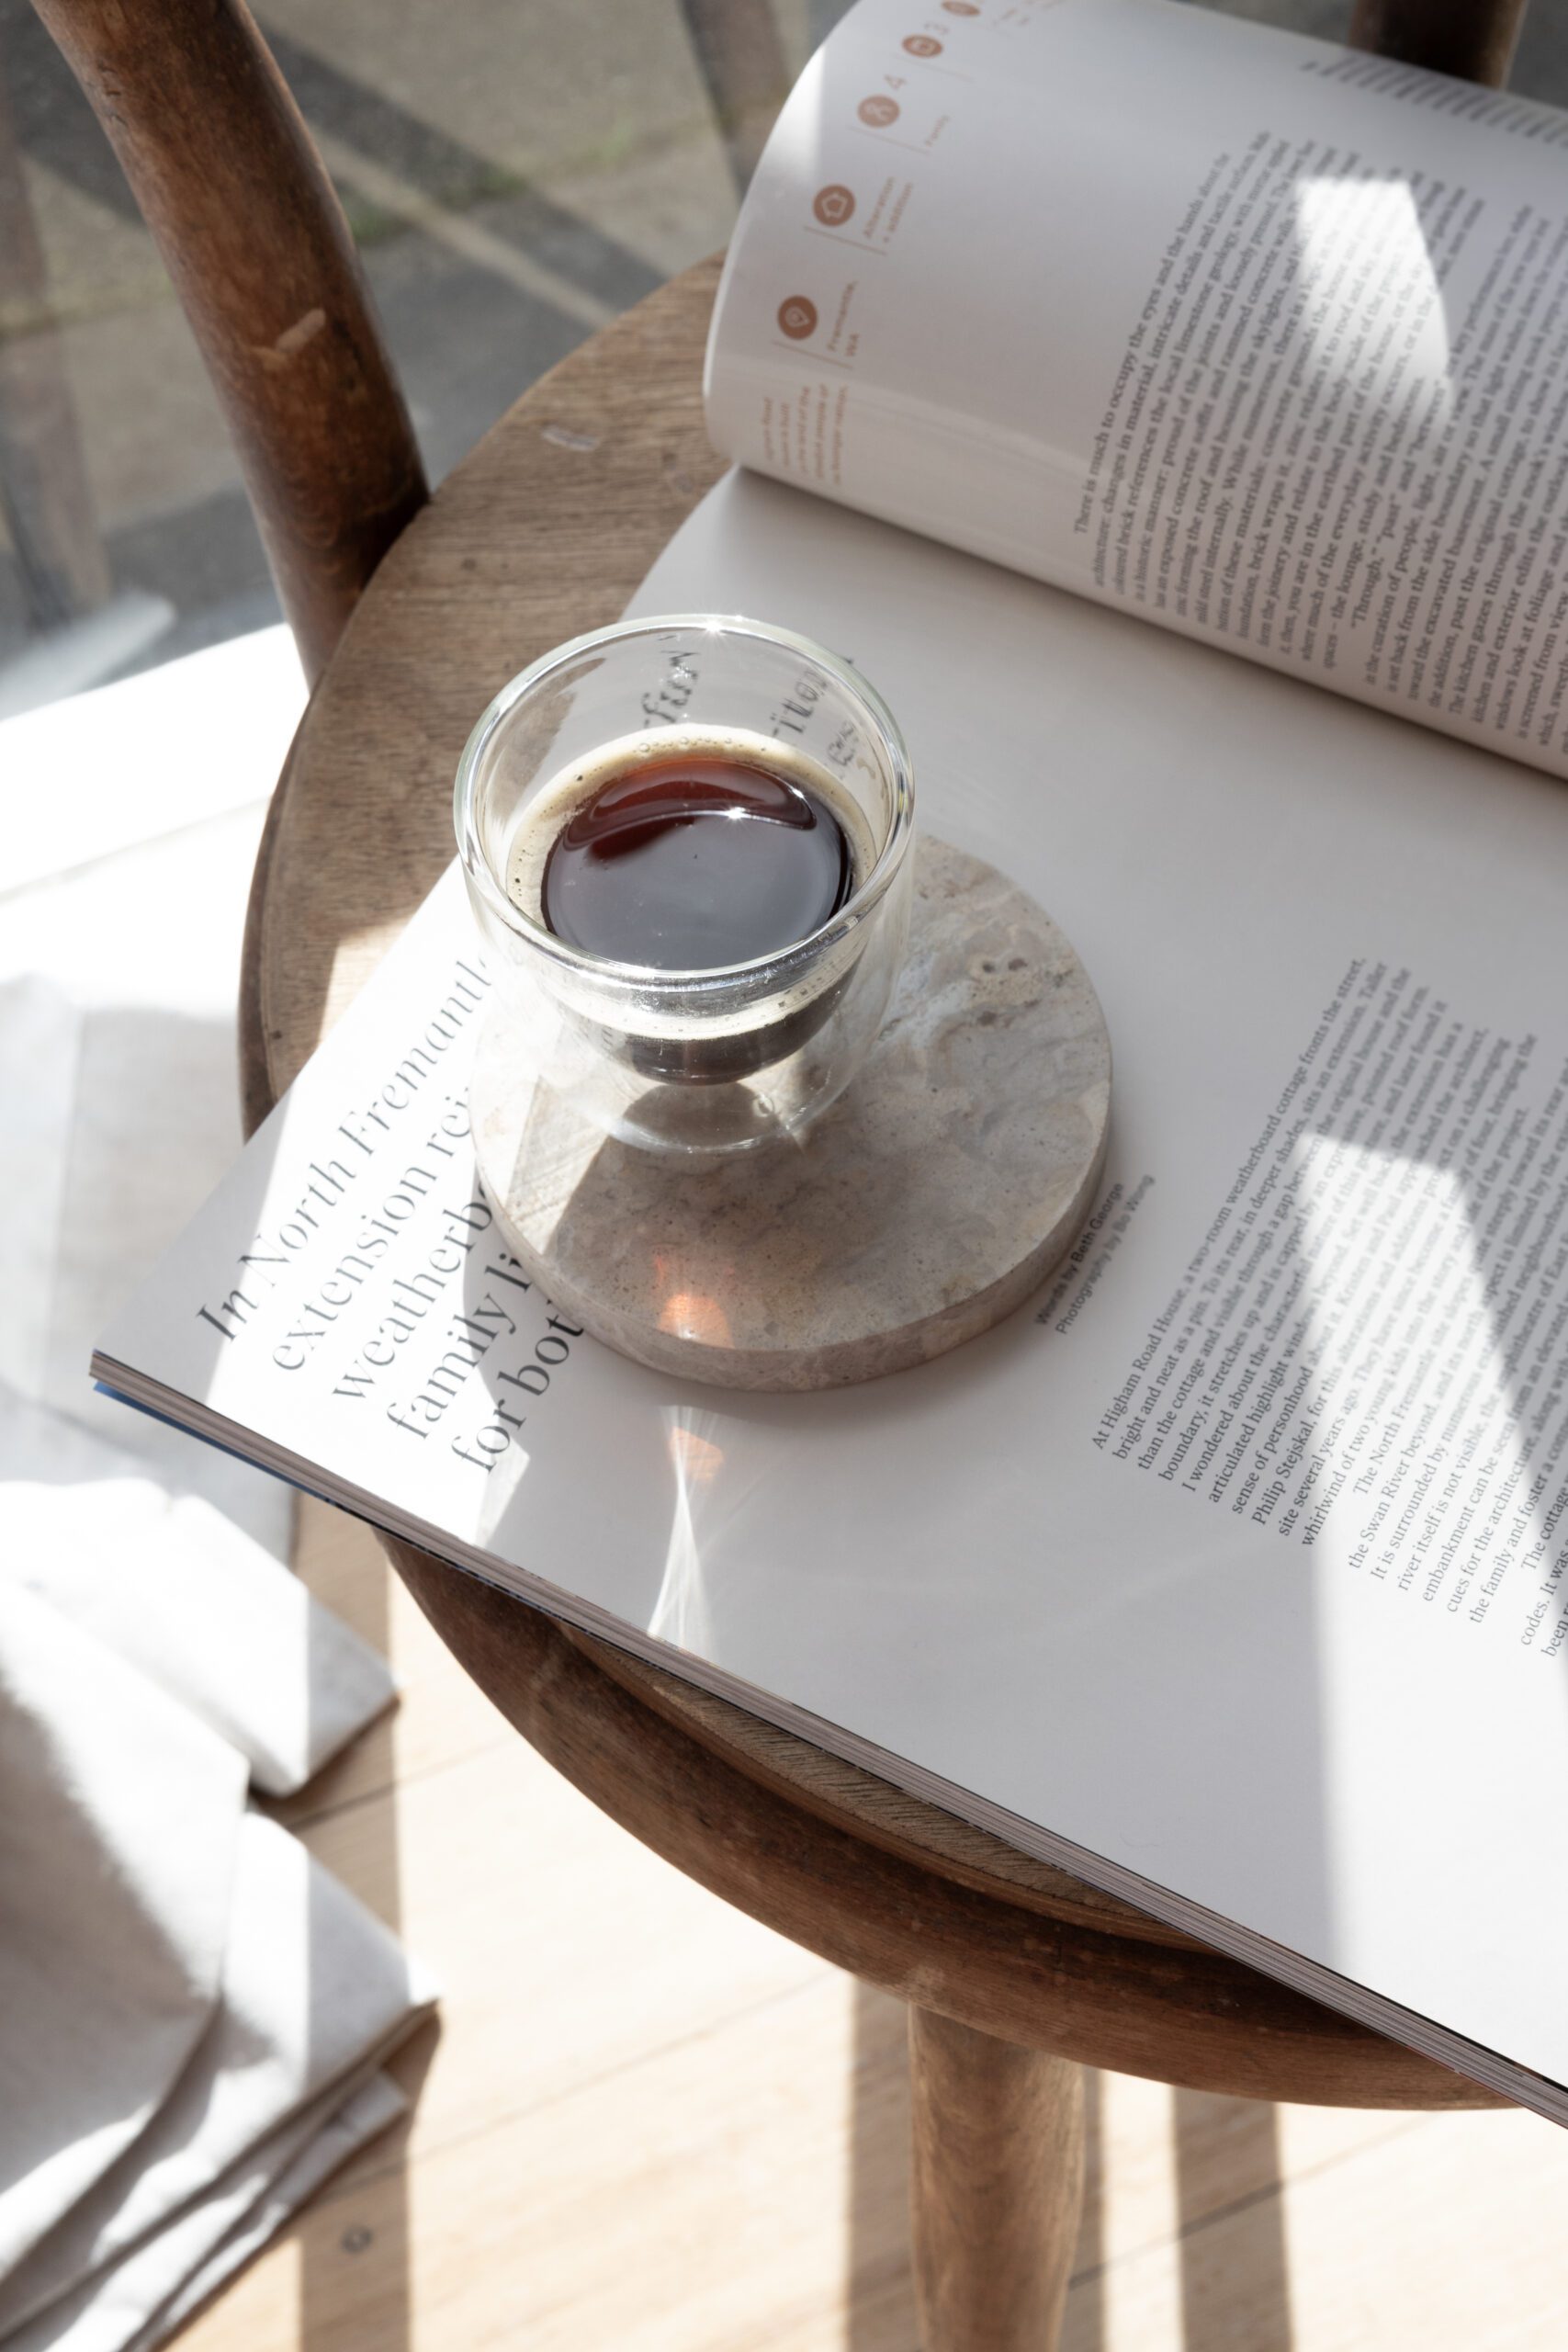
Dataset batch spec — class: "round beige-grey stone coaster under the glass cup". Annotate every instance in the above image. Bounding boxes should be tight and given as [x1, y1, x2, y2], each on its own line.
[478, 840, 1110, 1390]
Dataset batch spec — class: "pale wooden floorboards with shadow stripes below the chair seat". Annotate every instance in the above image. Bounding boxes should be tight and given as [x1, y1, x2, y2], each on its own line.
[184, 1508, 1568, 2352]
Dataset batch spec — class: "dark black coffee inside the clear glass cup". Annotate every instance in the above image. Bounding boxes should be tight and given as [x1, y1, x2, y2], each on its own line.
[541, 752, 856, 971]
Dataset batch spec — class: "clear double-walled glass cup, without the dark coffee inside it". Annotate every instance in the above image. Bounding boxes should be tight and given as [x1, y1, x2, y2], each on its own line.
[456, 614, 915, 1152]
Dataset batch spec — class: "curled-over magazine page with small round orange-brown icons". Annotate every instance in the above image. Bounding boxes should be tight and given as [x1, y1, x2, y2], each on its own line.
[707, 0, 1568, 774]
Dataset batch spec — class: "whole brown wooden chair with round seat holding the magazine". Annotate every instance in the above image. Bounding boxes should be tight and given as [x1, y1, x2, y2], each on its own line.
[35, 0, 1521, 2352]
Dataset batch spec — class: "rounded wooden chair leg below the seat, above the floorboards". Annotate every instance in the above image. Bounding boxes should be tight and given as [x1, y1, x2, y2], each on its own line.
[909, 2008, 1084, 2352]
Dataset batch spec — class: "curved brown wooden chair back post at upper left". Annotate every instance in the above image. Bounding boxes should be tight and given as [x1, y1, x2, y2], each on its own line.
[35, 0, 428, 682]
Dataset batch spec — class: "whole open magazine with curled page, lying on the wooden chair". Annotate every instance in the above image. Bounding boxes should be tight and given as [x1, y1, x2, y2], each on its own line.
[94, 0, 1568, 2121]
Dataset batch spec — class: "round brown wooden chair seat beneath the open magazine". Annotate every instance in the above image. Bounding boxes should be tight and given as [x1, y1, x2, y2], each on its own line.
[240, 261, 1502, 2108]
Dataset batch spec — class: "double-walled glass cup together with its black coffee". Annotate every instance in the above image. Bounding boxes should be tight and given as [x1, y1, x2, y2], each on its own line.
[454, 614, 915, 1152]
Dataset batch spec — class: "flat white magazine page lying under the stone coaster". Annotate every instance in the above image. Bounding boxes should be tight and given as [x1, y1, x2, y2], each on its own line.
[98, 475, 1568, 2120]
